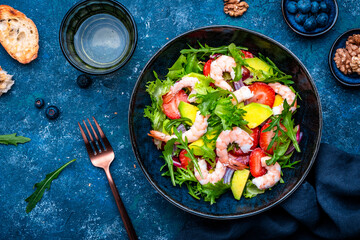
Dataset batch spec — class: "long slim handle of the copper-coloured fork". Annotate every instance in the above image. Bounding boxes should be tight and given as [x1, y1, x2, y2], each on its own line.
[104, 167, 138, 240]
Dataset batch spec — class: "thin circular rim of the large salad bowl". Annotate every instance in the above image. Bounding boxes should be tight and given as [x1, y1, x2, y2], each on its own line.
[128, 25, 323, 220]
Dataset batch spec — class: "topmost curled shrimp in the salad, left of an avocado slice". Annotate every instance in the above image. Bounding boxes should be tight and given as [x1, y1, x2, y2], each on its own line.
[210, 55, 236, 91]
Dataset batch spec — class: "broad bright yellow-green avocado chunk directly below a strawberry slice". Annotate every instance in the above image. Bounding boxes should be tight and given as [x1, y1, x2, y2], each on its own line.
[241, 103, 273, 128]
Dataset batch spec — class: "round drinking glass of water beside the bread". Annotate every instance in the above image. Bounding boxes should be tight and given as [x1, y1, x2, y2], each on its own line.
[59, 0, 137, 75]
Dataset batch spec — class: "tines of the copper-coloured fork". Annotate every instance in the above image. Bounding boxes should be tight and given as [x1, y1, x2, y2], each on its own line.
[78, 117, 111, 155]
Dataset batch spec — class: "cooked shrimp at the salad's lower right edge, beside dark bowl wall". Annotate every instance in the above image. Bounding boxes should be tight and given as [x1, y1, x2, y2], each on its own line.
[252, 157, 281, 190]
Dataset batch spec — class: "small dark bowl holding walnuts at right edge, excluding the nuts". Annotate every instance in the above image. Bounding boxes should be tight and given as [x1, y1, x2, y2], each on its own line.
[329, 28, 360, 87]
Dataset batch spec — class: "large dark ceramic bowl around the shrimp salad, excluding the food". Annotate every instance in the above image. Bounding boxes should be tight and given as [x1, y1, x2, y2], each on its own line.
[129, 26, 322, 219]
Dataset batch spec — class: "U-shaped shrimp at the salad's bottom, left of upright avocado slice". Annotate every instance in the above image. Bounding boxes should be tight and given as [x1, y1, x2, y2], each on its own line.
[194, 159, 226, 185]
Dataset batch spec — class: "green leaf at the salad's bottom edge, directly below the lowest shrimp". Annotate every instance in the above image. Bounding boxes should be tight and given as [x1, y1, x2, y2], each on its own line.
[198, 179, 230, 205]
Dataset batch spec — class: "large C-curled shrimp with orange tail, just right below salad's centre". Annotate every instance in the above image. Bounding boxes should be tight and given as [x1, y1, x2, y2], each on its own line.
[216, 127, 253, 169]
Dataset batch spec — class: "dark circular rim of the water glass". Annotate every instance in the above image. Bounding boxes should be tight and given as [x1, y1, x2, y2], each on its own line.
[59, 0, 138, 76]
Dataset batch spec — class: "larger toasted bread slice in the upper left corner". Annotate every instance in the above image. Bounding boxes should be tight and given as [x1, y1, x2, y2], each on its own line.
[0, 5, 39, 64]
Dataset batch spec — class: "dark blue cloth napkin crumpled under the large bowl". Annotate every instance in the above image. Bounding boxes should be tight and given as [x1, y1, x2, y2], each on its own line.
[179, 144, 360, 240]
